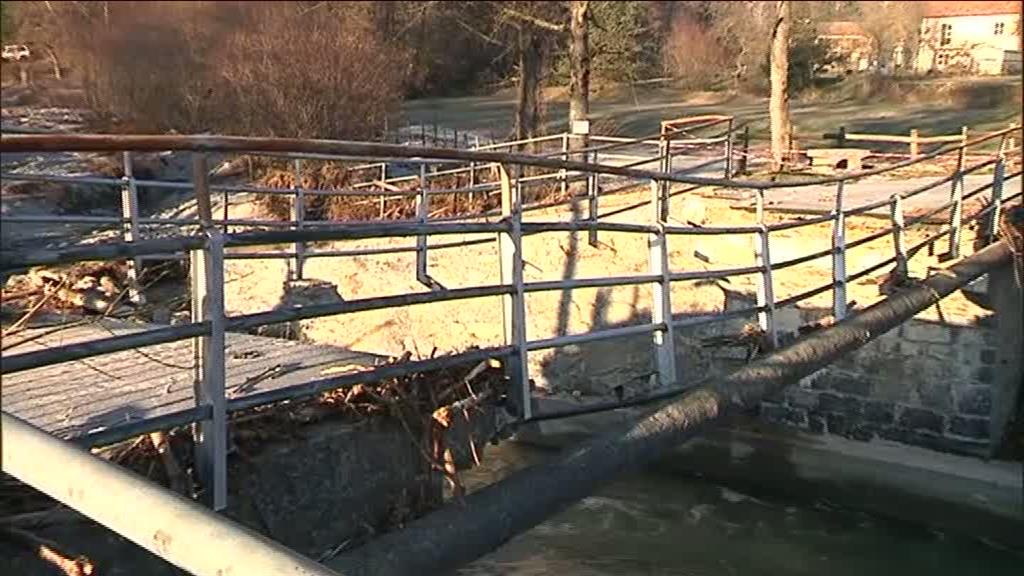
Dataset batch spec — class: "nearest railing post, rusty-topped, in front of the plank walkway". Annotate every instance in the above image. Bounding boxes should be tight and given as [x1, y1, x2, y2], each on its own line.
[189, 153, 227, 510]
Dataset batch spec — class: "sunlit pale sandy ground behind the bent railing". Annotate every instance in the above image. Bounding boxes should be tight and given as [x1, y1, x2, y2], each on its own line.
[227, 183, 983, 387]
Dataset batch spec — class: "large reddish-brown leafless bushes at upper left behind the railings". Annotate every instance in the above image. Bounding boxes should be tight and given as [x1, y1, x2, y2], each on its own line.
[48, 2, 409, 138]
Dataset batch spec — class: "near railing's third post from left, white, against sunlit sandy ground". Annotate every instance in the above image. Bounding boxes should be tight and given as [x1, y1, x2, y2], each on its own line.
[647, 180, 676, 386]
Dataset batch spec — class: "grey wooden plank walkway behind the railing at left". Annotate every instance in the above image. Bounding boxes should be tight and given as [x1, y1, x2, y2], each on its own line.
[0, 321, 383, 440]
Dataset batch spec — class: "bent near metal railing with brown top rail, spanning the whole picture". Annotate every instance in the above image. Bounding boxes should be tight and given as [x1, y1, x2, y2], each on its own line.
[0, 119, 1021, 509]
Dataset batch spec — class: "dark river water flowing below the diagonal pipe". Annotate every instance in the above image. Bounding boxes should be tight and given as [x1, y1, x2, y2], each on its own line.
[460, 443, 1024, 576]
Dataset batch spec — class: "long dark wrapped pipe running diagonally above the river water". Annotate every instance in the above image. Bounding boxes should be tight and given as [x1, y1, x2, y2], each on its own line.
[329, 242, 1012, 576]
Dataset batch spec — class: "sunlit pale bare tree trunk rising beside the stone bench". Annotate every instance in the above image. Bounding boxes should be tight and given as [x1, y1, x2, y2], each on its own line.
[768, 0, 793, 172]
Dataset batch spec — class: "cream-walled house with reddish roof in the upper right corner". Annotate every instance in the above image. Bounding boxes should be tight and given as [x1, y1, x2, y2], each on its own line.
[914, 1, 1021, 75]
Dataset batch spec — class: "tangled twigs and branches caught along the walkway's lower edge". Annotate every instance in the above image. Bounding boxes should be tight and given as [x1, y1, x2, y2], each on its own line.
[0, 354, 506, 576]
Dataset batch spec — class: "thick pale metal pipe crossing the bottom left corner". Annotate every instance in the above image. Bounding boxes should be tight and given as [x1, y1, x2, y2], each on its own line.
[0, 412, 338, 576]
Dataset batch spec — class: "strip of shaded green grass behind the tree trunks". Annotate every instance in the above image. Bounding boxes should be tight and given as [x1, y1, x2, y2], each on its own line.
[404, 78, 1021, 147]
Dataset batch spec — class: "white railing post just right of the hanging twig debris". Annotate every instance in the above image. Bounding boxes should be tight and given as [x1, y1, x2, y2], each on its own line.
[498, 164, 532, 419]
